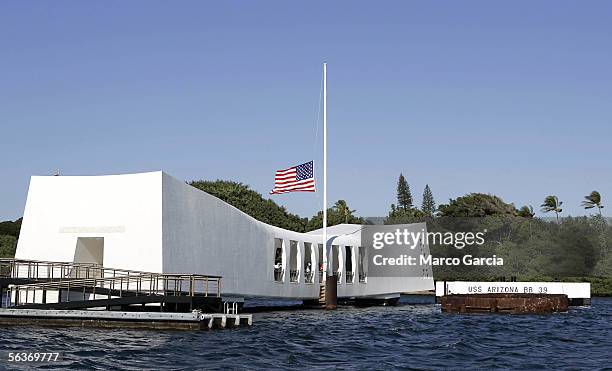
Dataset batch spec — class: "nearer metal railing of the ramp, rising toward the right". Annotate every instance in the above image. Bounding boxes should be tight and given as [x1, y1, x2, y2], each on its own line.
[3, 273, 221, 307]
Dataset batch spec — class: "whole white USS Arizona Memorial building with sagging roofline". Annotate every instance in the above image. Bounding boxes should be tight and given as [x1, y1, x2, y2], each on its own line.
[16, 171, 434, 300]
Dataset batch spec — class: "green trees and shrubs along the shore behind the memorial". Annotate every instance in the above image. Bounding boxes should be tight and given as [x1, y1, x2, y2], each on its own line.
[0, 179, 612, 296]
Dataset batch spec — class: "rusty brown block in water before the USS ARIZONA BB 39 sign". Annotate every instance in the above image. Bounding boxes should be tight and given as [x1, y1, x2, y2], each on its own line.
[440, 294, 569, 314]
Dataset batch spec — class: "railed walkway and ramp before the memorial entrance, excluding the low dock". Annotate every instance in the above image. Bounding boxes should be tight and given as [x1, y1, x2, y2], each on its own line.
[0, 259, 222, 312]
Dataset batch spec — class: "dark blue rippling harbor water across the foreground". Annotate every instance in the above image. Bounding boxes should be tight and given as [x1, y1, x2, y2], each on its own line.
[0, 297, 612, 370]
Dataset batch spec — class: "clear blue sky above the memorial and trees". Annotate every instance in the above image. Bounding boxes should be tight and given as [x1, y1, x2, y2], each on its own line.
[0, 1, 612, 220]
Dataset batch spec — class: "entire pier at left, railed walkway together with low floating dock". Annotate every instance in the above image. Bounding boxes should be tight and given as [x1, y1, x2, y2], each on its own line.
[0, 259, 253, 329]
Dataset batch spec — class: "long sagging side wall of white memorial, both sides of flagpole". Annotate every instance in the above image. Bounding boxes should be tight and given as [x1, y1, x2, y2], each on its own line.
[163, 174, 433, 299]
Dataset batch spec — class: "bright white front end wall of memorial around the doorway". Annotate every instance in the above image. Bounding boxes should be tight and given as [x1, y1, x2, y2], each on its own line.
[16, 172, 162, 272]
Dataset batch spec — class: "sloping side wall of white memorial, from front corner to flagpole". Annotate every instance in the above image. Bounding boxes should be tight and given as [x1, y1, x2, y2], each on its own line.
[163, 174, 319, 298]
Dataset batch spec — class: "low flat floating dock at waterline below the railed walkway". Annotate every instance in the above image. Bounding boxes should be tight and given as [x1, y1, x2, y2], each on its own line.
[0, 309, 253, 330]
